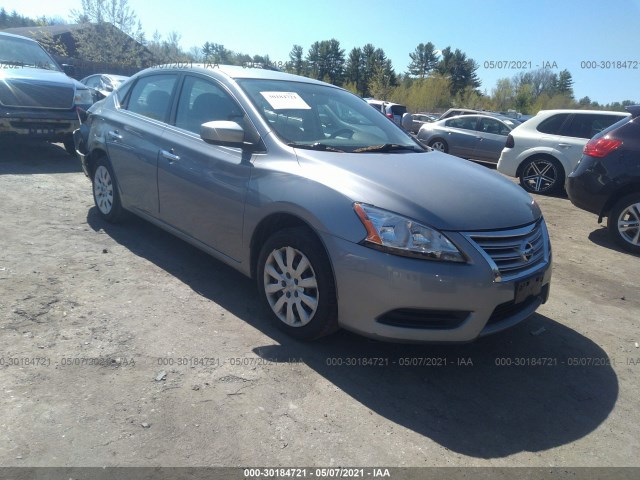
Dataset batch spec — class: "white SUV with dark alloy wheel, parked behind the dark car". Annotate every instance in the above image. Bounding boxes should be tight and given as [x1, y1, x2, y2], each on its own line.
[498, 110, 629, 194]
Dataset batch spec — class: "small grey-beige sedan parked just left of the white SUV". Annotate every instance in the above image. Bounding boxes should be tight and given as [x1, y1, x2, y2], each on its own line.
[418, 115, 520, 163]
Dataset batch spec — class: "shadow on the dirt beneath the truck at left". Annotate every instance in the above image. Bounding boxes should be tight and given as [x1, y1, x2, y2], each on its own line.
[0, 139, 82, 175]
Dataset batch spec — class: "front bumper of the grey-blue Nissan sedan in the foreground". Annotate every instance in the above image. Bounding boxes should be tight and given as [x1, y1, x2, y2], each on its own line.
[323, 231, 551, 343]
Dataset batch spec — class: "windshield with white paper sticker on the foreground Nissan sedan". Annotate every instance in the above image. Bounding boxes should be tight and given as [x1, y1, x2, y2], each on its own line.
[238, 79, 425, 153]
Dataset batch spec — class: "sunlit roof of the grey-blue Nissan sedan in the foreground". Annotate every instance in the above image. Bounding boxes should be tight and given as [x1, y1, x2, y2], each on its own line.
[146, 62, 339, 88]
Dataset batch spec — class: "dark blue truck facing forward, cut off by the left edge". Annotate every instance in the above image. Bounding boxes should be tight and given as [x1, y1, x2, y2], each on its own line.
[0, 33, 93, 155]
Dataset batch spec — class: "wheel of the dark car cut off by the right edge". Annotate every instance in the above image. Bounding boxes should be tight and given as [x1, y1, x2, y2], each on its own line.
[607, 193, 640, 254]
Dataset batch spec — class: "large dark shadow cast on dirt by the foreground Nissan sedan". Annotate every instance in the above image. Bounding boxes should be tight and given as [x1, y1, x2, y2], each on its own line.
[87, 208, 618, 459]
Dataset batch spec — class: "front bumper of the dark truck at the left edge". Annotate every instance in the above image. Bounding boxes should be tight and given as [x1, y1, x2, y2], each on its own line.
[0, 108, 80, 141]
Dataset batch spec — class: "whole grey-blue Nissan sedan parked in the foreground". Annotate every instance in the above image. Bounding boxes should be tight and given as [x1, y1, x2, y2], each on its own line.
[74, 65, 551, 342]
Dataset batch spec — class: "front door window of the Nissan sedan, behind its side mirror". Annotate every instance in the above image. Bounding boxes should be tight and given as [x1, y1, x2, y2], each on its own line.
[176, 76, 244, 134]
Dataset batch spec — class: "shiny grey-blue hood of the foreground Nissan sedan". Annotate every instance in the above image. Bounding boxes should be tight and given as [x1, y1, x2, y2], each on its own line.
[296, 149, 541, 231]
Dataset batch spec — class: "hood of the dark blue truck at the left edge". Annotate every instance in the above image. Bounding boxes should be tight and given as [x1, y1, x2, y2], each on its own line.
[0, 67, 86, 109]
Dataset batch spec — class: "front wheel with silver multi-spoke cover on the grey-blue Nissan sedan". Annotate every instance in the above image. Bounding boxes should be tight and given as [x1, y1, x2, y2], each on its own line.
[256, 227, 338, 340]
